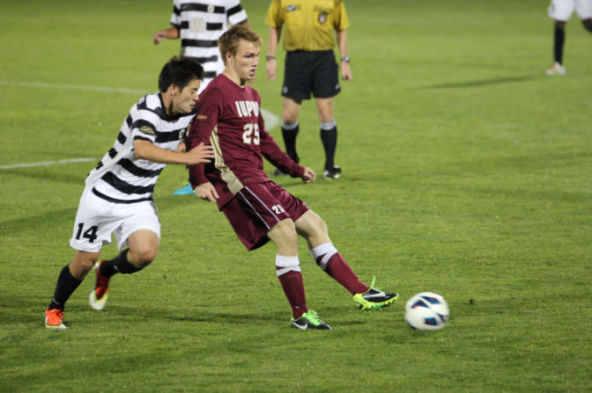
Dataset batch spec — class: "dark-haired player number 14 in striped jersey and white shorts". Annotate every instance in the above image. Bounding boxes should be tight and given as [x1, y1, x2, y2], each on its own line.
[45, 57, 213, 329]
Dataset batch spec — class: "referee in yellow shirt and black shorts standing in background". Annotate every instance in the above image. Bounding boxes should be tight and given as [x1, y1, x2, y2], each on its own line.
[265, 0, 352, 179]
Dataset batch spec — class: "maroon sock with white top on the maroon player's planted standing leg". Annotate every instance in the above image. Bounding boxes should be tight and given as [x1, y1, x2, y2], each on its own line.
[275, 255, 308, 319]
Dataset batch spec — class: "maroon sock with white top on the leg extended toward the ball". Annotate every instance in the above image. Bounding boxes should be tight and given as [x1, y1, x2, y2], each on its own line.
[310, 243, 370, 295]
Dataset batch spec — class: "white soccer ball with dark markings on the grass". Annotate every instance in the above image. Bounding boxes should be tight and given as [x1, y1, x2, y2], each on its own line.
[405, 292, 450, 330]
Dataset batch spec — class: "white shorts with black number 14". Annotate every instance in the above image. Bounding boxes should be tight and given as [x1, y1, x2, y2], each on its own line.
[70, 187, 160, 252]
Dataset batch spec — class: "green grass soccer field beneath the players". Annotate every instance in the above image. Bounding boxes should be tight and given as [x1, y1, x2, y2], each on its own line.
[0, 0, 592, 393]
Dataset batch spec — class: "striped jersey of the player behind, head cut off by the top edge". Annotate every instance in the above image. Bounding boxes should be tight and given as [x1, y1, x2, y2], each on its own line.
[171, 0, 247, 90]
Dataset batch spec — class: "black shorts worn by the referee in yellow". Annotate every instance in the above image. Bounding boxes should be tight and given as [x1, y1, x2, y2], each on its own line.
[282, 50, 341, 101]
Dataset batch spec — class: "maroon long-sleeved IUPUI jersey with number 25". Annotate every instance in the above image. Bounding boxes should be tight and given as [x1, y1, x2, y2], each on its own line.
[187, 74, 304, 208]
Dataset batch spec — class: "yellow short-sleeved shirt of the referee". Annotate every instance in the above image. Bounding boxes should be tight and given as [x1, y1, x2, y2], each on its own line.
[265, 0, 349, 51]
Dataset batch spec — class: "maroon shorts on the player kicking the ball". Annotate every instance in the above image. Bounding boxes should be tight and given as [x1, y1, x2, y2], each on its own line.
[222, 181, 308, 250]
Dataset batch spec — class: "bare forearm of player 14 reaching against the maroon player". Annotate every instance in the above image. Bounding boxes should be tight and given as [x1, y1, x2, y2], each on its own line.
[134, 139, 214, 165]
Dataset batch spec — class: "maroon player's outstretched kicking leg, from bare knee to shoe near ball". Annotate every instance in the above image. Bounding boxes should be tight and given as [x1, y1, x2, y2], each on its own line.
[295, 210, 399, 311]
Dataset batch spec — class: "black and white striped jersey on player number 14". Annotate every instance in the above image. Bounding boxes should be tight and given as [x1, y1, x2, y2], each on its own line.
[86, 93, 195, 203]
